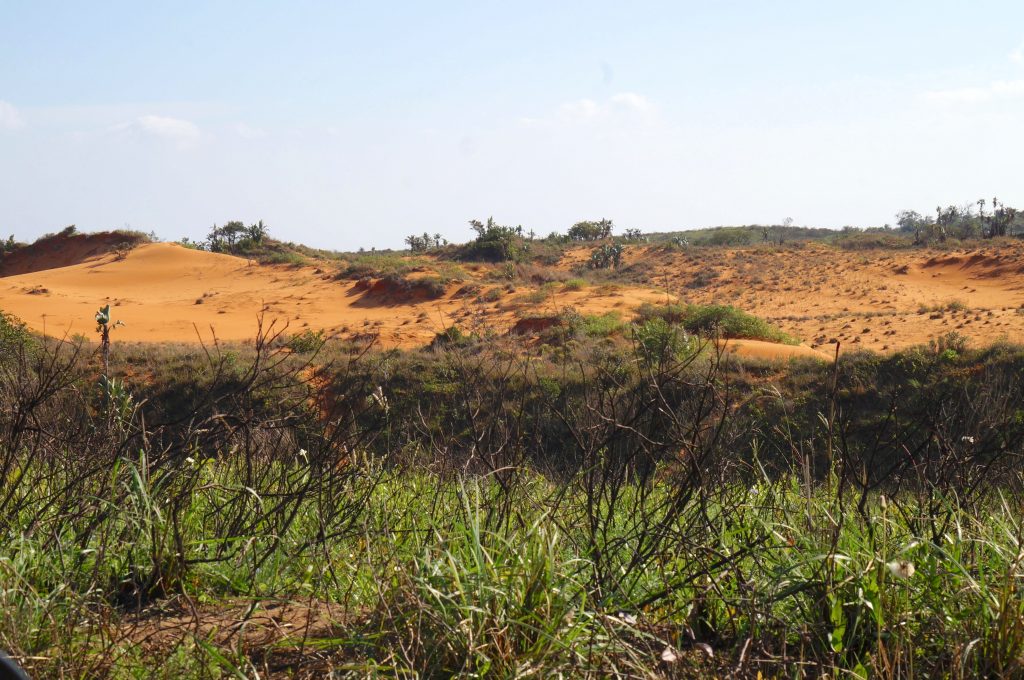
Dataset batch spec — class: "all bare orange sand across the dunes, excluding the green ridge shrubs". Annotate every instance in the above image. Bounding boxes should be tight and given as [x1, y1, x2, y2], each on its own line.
[0, 237, 1024, 358]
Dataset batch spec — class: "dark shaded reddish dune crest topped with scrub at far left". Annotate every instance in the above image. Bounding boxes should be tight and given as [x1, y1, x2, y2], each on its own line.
[0, 226, 150, 277]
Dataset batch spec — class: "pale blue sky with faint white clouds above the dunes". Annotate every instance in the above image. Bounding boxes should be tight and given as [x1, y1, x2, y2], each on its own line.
[0, 0, 1024, 250]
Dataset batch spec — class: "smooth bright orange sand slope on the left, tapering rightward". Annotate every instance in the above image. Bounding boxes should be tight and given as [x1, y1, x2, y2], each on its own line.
[0, 244, 666, 347]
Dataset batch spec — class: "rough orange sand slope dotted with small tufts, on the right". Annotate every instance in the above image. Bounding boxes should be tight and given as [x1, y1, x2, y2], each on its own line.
[602, 241, 1024, 354]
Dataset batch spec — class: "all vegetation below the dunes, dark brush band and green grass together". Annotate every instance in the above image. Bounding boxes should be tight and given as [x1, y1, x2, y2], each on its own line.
[0, 313, 1024, 678]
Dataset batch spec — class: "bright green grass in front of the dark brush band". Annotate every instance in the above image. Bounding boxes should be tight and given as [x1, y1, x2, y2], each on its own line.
[0, 456, 1024, 677]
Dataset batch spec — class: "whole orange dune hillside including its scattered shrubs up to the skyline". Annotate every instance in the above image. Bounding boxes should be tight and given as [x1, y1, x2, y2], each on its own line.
[0, 222, 1024, 357]
